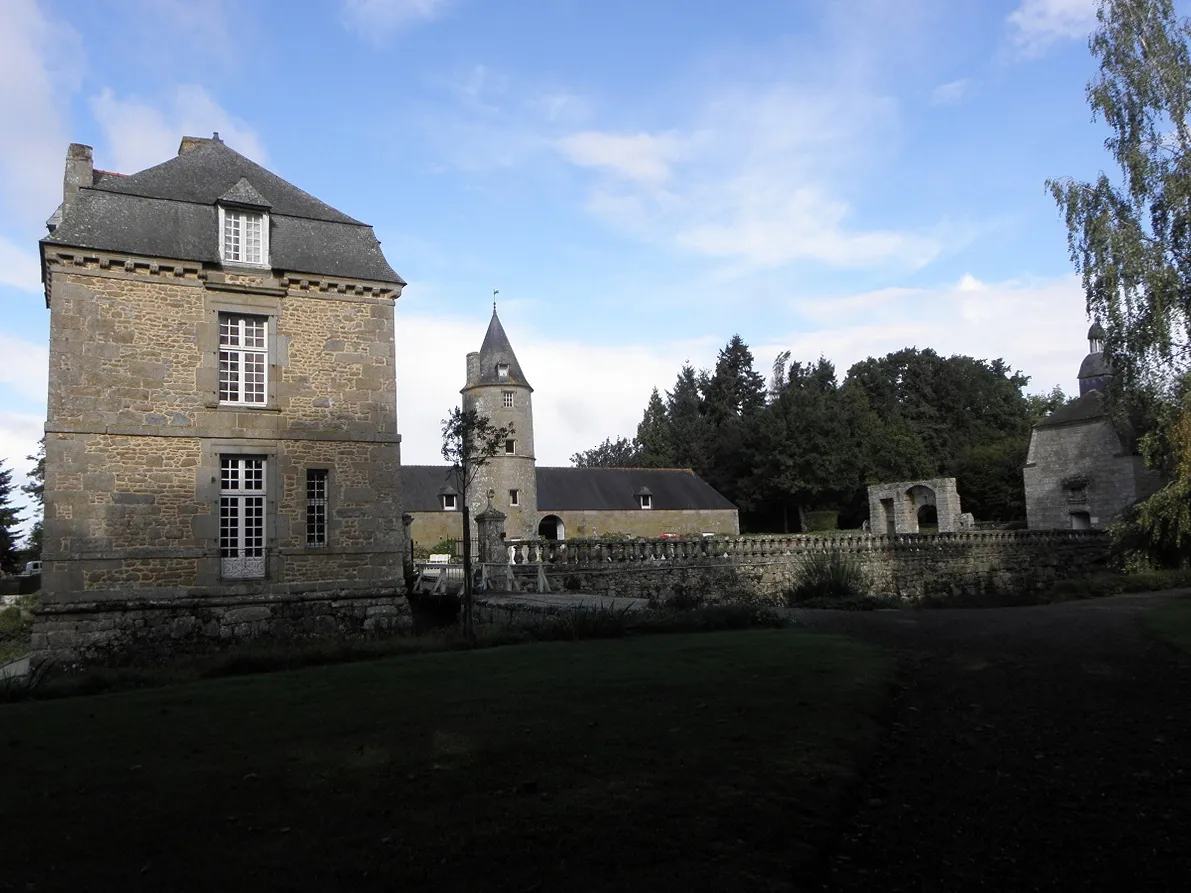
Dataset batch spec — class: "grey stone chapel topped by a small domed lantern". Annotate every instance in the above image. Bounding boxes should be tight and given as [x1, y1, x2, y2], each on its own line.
[1023, 321, 1164, 530]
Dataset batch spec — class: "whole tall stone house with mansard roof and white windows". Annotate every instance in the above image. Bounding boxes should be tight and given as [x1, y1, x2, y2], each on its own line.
[33, 133, 405, 654]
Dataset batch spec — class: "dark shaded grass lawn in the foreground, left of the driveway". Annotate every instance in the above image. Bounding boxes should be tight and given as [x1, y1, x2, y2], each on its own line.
[0, 630, 892, 891]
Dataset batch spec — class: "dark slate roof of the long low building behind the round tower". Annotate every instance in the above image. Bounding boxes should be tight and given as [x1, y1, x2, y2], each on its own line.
[401, 466, 736, 512]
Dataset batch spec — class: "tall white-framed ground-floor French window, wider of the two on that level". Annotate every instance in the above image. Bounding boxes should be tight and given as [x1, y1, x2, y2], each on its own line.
[219, 456, 264, 580]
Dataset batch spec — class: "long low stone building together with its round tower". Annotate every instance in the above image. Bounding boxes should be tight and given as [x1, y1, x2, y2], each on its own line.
[401, 307, 740, 547]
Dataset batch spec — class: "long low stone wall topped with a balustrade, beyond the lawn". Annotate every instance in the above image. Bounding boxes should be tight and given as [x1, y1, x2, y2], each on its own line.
[509, 531, 1109, 604]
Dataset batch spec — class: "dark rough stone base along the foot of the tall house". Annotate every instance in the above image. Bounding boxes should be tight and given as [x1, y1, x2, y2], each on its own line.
[31, 591, 411, 666]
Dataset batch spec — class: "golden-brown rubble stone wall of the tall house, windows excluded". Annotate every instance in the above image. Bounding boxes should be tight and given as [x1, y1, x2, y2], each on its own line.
[35, 249, 404, 656]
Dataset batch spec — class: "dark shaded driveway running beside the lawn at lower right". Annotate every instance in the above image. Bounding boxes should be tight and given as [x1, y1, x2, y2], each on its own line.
[792, 593, 1191, 892]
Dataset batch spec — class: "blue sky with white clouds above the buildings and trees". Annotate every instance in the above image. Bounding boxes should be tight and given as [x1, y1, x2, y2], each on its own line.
[0, 0, 1109, 531]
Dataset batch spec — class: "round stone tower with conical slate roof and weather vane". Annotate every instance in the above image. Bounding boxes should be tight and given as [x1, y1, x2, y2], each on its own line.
[461, 305, 537, 537]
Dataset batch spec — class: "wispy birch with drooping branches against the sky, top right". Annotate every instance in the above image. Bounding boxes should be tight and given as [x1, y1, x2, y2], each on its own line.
[1047, 0, 1191, 391]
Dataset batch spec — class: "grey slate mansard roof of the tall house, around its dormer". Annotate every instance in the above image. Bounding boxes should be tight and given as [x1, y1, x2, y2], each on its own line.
[42, 139, 405, 285]
